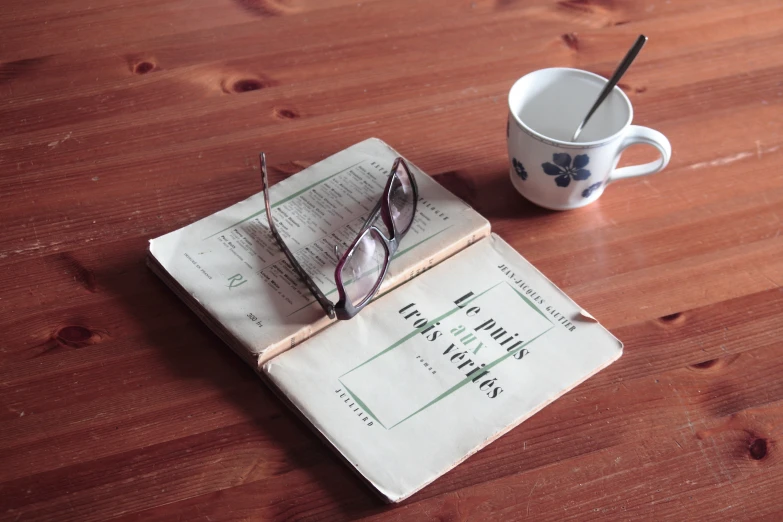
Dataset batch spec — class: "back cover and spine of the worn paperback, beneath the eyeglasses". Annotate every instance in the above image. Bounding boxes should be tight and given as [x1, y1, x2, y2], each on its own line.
[150, 139, 489, 363]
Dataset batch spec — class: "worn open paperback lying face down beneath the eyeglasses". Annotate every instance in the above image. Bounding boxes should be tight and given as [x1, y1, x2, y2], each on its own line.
[148, 139, 622, 502]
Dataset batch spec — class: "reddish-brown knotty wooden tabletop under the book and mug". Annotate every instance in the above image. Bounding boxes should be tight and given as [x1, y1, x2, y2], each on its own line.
[0, 0, 783, 521]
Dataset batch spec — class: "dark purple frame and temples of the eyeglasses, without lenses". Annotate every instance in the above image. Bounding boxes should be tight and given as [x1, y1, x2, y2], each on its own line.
[259, 152, 419, 320]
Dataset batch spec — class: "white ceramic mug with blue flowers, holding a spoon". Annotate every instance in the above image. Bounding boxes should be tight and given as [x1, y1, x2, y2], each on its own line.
[507, 68, 671, 210]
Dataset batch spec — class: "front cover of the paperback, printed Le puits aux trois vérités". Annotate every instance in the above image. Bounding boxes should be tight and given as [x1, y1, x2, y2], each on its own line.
[263, 235, 622, 502]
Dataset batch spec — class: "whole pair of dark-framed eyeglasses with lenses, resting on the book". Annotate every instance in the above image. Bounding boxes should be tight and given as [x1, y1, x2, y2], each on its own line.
[260, 152, 419, 319]
